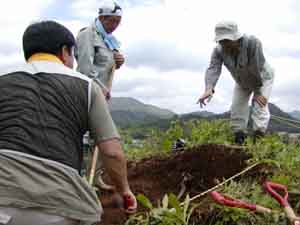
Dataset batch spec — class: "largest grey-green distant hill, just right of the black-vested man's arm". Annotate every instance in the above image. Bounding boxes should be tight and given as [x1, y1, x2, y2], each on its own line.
[109, 97, 176, 127]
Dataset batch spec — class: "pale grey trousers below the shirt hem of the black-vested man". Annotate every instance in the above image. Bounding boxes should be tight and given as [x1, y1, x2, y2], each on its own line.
[0, 207, 79, 225]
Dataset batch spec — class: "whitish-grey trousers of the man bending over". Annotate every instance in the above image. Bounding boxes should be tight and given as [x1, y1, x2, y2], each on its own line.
[231, 70, 274, 132]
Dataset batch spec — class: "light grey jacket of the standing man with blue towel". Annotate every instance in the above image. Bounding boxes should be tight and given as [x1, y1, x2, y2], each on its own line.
[75, 22, 115, 88]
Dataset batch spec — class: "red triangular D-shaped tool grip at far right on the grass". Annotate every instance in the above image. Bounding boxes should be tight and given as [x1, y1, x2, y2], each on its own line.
[264, 181, 289, 207]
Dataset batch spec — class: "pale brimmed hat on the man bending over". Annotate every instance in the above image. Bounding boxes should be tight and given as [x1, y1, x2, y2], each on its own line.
[215, 21, 243, 42]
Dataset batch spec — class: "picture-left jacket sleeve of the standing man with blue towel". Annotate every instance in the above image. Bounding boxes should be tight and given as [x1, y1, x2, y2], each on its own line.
[75, 28, 106, 88]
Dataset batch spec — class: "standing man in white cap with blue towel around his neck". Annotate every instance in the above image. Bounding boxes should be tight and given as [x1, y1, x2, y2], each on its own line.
[75, 0, 125, 99]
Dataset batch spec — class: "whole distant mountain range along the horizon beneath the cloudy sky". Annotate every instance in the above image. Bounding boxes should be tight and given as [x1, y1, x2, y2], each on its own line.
[109, 97, 300, 133]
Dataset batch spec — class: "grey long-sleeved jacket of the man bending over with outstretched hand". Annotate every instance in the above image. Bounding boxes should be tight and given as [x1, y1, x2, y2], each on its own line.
[205, 35, 274, 92]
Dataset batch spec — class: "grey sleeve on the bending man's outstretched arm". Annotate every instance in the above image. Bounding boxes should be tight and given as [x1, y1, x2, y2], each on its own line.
[205, 46, 223, 90]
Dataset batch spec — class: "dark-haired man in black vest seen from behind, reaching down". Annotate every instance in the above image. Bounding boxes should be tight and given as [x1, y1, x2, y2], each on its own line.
[0, 21, 137, 225]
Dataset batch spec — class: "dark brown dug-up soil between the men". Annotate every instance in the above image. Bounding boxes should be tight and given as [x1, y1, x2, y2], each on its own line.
[99, 144, 249, 225]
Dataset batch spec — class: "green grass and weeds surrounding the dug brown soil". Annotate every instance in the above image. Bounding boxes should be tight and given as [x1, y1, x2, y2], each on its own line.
[123, 120, 300, 225]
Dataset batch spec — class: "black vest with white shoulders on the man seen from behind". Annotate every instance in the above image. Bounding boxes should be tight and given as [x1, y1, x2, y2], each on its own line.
[0, 61, 90, 171]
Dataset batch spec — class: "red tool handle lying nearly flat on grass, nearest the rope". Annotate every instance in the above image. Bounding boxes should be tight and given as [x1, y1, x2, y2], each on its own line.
[210, 191, 256, 211]
